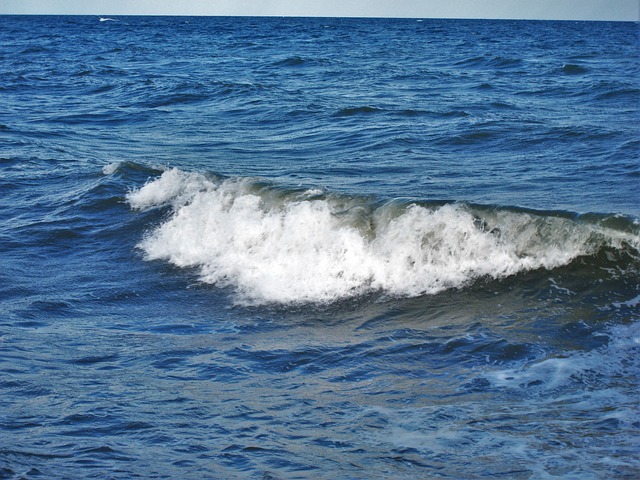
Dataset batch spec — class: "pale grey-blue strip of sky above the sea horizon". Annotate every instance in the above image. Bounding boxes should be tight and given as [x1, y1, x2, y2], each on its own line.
[0, 0, 640, 21]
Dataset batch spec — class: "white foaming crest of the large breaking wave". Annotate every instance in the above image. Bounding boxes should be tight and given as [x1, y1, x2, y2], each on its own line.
[127, 168, 640, 303]
